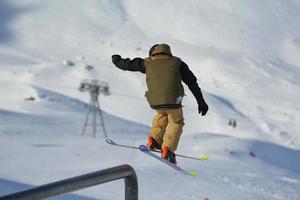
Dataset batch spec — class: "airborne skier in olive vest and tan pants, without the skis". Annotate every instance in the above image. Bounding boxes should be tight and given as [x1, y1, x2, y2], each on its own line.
[112, 44, 208, 164]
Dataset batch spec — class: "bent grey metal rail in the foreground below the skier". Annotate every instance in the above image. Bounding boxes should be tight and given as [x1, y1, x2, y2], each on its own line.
[0, 165, 138, 200]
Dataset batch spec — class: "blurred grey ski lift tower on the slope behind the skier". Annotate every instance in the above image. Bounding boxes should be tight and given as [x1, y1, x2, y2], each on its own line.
[79, 80, 110, 139]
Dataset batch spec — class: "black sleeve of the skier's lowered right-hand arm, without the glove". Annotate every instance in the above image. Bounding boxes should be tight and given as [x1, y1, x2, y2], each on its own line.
[180, 61, 205, 104]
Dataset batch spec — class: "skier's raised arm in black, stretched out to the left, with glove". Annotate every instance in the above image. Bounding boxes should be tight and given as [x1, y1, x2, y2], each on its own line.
[111, 55, 146, 73]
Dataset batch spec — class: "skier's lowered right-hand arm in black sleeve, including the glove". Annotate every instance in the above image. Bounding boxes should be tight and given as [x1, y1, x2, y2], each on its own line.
[180, 62, 208, 115]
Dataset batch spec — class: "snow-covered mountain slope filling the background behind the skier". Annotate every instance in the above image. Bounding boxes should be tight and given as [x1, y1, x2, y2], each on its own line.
[0, 0, 300, 200]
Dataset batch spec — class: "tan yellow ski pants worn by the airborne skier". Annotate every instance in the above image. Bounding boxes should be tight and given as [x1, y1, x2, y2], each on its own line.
[149, 108, 184, 152]
